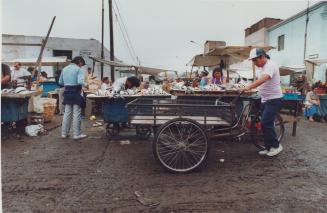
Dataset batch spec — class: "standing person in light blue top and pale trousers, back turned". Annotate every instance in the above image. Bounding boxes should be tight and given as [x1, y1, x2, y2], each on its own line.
[59, 56, 87, 140]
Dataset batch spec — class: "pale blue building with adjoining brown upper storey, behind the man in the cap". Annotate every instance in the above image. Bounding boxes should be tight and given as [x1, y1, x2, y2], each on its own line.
[245, 1, 327, 67]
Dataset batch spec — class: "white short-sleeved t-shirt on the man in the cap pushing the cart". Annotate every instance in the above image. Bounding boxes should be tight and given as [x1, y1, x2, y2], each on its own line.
[257, 60, 283, 103]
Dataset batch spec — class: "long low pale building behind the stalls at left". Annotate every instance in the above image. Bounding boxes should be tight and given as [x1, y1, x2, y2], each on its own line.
[2, 34, 120, 79]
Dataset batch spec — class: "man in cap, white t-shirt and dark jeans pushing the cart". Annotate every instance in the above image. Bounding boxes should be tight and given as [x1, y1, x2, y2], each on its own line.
[243, 48, 283, 156]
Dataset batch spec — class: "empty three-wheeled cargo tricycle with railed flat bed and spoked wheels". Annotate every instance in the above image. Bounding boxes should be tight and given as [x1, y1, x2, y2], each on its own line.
[127, 95, 284, 172]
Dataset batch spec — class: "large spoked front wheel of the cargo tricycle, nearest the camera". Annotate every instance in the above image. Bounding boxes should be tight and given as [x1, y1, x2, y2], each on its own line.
[153, 118, 209, 173]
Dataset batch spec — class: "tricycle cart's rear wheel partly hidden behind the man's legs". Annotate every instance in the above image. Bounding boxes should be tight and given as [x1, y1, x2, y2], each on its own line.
[253, 114, 285, 150]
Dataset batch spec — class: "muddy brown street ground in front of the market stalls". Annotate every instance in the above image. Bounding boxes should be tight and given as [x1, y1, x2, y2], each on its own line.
[1, 120, 327, 212]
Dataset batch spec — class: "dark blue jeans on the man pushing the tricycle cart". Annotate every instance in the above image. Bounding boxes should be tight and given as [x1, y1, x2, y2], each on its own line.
[261, 98, 283, 150]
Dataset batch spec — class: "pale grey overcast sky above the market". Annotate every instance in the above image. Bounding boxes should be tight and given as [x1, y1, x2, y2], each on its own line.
[1, 0, 317, 70]
